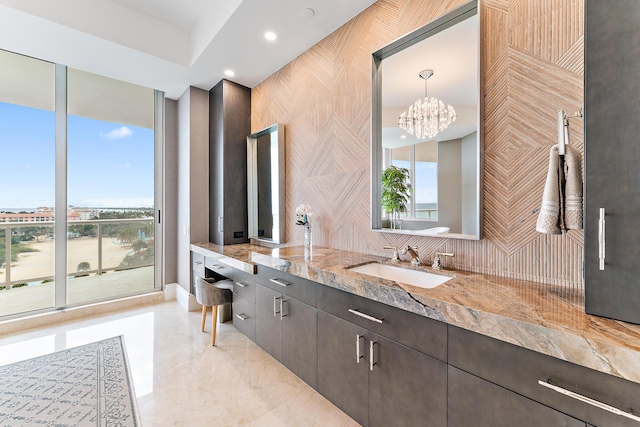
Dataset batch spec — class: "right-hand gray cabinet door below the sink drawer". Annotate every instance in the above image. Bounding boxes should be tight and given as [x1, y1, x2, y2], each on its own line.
[369, 334, 448, 427]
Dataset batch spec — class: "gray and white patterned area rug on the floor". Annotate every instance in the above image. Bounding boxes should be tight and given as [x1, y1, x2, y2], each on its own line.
[0, 336, 140, 427]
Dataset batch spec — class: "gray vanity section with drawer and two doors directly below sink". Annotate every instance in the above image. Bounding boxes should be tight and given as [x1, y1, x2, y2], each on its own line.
[318, 286, 447, 427]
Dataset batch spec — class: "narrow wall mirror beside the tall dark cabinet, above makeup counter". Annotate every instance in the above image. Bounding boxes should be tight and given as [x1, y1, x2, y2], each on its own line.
[247, 124, 286, 243]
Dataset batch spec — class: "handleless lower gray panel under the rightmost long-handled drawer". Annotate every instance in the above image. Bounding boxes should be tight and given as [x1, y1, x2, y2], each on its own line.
[450, 366, 585, 427]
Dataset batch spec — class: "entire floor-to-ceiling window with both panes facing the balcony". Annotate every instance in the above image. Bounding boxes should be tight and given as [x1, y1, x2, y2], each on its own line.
[0, 51, 163, 316]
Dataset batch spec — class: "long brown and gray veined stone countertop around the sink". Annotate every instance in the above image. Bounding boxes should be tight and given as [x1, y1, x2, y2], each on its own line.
[191, 243, 640, 383]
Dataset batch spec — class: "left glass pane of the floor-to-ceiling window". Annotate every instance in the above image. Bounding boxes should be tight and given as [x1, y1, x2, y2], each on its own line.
[0, 51, 55, 316]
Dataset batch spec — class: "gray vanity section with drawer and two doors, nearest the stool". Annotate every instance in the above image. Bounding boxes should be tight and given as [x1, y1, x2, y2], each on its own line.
[255, 266, 318, 388]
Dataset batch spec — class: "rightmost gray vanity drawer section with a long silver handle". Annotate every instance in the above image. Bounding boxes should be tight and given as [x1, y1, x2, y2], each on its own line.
[449, 325, 640, 427]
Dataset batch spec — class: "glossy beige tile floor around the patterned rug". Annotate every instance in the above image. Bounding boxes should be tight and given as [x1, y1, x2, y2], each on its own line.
[0, 301, 358, 427]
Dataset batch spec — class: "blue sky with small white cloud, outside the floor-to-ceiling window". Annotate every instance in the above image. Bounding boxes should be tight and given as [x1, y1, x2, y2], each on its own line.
[0, 102, 154, 210]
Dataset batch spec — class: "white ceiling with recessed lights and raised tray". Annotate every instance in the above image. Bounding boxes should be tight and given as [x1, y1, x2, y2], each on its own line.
[0, 0, 375, 99]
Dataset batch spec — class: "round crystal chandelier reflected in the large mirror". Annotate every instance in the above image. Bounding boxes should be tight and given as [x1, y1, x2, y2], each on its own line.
[398, 70, 456, 138]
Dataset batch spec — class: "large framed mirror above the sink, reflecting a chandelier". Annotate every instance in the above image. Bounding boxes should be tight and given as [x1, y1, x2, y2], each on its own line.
[371, 0, 483, 240]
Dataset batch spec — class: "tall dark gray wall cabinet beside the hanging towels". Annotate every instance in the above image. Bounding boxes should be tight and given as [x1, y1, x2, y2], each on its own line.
[584, 0, 640, 324]
